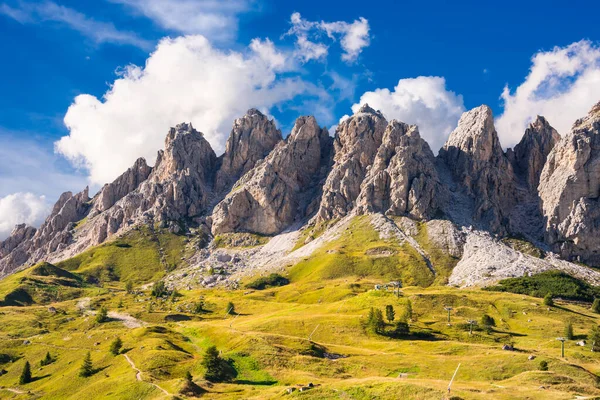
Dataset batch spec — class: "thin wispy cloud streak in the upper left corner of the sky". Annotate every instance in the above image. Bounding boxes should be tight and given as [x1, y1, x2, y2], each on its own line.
[0, 1, 152, 49]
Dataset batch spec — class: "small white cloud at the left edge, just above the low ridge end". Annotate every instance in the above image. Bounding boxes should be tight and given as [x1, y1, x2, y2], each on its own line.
[0, 192, 50, 240]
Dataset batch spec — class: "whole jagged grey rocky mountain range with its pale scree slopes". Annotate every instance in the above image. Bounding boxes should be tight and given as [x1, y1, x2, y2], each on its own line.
[0, 100, 600, 285]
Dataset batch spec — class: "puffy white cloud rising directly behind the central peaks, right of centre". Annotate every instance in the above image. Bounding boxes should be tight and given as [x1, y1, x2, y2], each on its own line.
[354, 76, 465, 154]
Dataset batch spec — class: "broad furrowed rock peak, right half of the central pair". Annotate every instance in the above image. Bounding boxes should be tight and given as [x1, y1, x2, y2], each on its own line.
[356, 120, 442, 218]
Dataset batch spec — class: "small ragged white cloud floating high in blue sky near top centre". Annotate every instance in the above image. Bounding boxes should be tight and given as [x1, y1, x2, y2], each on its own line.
[284, 12, 370, 63]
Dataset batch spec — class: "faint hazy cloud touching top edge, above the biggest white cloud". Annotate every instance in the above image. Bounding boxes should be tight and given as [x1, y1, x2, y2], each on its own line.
[110, 0, 253, 42]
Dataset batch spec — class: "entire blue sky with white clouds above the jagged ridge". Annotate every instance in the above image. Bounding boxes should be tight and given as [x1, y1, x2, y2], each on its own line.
[0, 0, 600, 239]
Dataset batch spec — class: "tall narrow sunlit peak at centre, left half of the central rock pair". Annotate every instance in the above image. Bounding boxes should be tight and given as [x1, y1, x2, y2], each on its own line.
[317, 104, 387, 221]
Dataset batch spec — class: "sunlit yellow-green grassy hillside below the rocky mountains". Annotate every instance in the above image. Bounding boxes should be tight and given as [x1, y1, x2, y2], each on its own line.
[0, 218, 600, 399]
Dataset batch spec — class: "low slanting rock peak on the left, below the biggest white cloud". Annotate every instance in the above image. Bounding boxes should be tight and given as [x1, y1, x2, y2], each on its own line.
[89, 157, 152, 217]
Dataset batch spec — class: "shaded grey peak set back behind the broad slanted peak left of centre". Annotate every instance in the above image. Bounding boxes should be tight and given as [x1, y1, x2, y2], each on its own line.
[215, 108, 283, 192]
